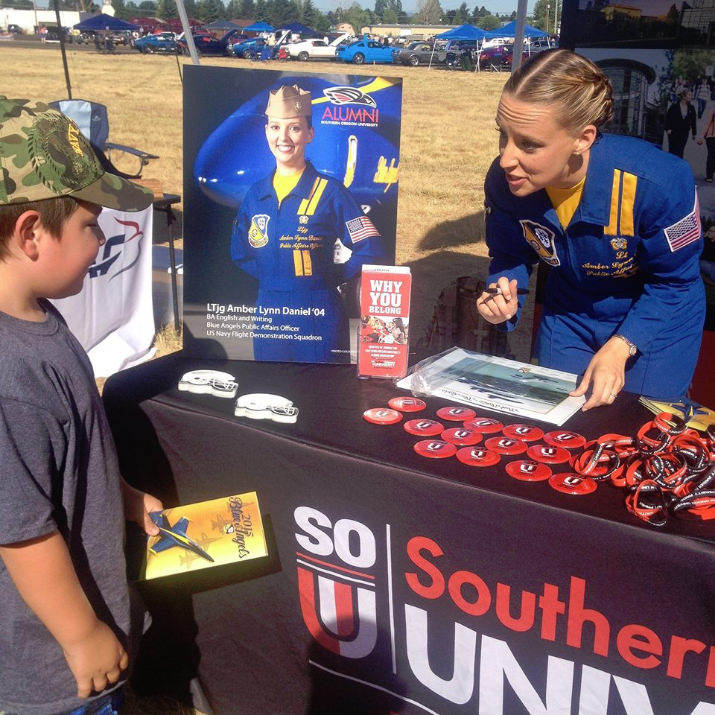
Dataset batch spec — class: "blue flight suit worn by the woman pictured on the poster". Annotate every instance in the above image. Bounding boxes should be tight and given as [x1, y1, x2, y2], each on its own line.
[231, 162, 382, 362]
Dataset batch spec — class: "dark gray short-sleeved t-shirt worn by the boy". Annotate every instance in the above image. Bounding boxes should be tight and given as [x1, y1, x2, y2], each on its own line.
[0, 302, 141, 715]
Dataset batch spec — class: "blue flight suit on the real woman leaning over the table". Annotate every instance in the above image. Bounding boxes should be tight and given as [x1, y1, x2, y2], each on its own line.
[484, 134, 705, 400]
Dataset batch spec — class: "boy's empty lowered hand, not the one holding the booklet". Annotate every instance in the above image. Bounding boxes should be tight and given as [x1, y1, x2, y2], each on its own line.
[63, 620, 129, 698]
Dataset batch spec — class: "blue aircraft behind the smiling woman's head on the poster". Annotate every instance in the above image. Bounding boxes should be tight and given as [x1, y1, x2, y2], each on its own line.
[193, 75, 402, 208]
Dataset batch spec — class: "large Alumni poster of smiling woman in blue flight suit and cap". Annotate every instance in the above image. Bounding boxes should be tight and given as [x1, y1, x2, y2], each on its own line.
[184, 66, 402, 363]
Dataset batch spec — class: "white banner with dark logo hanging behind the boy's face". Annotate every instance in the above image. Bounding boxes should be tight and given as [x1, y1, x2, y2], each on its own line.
[53, 207, 155, 377]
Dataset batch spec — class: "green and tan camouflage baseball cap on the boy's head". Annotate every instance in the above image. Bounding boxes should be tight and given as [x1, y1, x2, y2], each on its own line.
[0, 95, 153, 211]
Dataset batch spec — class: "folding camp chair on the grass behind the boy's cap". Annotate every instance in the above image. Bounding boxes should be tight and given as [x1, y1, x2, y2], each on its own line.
[50, 99, 159, 179]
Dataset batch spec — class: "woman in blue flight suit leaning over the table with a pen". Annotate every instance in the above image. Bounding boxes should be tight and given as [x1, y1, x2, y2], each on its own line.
[477, 50, 705, 410]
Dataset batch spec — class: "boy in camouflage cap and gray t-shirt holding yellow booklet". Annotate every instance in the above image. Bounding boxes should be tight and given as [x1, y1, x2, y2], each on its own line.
[0, 96, 161, 715]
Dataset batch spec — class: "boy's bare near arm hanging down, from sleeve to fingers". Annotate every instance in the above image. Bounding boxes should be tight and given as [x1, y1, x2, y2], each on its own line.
[0, 531, 129, 698]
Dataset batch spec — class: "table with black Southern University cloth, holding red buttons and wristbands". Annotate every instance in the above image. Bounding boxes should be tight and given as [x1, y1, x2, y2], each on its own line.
[104, 353, 715, 715]
